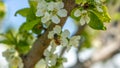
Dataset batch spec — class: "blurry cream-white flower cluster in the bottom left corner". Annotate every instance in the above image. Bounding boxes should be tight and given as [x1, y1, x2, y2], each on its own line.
[2, 48, 23, 68]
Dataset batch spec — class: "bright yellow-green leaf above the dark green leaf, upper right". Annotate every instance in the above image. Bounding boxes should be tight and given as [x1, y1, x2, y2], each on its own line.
[92, 6, 111, 22]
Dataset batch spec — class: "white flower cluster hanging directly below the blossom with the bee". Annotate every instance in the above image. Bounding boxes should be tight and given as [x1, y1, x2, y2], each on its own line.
[44, 43, 66, 68]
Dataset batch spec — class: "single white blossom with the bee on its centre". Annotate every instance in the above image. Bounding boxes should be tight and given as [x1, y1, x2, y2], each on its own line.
[48, 25, 70, 46]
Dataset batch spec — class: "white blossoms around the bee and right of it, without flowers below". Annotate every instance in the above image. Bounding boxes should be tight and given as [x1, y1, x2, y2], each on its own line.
[48, 25, 80, 50]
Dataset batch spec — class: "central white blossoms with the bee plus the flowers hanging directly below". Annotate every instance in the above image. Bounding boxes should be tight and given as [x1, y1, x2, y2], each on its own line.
[44, 25, 80, 68]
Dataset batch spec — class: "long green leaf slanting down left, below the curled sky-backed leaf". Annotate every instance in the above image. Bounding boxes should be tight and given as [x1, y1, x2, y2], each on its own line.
[19, 19, 40, 32]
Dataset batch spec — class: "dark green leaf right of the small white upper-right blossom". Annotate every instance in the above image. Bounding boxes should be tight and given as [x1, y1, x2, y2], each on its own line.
[88, 12, 106, 30]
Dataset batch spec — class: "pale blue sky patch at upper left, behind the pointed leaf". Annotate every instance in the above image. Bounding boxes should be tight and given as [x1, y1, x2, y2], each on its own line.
[1, 0, 29, 32]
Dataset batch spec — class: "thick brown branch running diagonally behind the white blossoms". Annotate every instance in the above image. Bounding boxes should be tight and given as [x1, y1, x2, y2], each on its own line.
[23, 0, 76, 68]
